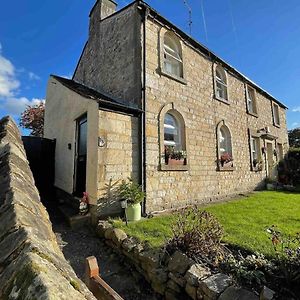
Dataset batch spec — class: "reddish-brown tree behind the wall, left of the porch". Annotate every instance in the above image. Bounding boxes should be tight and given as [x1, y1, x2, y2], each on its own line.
[20, 101, 45, 137]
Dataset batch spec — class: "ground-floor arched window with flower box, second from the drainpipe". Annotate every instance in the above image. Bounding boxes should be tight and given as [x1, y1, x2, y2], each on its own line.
[217, 121, 233, 170]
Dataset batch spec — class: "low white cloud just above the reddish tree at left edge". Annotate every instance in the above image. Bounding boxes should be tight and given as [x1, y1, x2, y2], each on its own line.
[0, 97, 45, 116]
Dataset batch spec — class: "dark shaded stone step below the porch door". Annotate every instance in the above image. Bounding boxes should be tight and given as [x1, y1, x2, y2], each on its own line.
[58, 204, 91, 229]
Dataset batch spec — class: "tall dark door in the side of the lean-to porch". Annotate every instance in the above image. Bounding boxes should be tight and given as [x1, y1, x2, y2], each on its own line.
[74, 115, 87, 197]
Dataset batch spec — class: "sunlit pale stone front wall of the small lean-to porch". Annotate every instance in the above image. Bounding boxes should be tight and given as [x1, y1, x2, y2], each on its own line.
[98, 110, 140, 216]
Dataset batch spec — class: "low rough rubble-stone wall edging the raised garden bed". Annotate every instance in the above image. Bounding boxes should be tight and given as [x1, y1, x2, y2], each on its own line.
[97, 221, 260, 300]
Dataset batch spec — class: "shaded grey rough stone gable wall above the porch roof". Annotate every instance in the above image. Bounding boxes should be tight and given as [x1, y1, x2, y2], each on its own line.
[74, 1, 141, 106]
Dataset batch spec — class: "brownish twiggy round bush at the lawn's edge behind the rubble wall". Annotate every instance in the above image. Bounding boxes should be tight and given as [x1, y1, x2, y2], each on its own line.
[167, 207, 224, 264]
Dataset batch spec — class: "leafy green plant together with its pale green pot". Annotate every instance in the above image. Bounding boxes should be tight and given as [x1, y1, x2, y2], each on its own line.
[118, 179, 146, 221]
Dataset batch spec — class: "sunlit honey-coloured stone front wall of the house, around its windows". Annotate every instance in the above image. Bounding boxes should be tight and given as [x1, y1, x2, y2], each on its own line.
[146, 18, 288, 211]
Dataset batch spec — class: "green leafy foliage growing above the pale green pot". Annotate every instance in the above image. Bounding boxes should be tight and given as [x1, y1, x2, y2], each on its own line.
[117, 179, 146, 204]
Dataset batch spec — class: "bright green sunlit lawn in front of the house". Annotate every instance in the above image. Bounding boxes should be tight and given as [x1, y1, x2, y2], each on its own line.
[114, 191, 300, 256]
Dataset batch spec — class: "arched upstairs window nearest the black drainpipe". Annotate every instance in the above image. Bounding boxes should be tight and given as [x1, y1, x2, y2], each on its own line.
[164, 32, 183, 78]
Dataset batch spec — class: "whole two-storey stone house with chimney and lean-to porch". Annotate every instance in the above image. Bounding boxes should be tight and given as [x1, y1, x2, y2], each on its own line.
[44, 0, 288, 215]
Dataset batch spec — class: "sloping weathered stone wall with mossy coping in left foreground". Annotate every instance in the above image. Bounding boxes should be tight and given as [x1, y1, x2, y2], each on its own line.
[0, 117, 95, 299]
